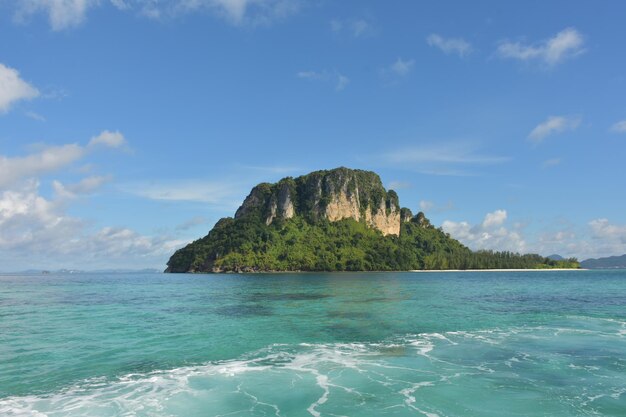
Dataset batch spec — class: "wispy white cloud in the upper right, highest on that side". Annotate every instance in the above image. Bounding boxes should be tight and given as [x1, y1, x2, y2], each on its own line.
[498, 28, 585, 67]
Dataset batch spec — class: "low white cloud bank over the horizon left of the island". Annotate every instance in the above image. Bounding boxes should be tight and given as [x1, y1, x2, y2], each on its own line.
[0, 179, 185, 268]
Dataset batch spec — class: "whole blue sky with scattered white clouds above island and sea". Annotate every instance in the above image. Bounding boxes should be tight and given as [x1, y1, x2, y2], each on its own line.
[0, 0, 626, 271]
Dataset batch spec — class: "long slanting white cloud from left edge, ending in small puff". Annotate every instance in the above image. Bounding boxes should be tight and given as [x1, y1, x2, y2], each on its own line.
[0, 130, 125, 188]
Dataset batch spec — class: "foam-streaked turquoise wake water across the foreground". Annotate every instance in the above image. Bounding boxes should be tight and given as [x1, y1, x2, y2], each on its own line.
[0, 317, 626, 417]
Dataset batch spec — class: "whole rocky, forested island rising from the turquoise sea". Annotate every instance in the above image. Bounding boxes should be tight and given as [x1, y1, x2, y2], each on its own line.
[165, 167, 579, 273]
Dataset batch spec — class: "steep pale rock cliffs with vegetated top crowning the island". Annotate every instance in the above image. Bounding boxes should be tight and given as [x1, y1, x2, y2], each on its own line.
[235, 168, 400, 235]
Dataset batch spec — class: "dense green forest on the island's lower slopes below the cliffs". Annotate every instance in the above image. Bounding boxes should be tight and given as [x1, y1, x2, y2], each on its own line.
[168, 213, 578, 272]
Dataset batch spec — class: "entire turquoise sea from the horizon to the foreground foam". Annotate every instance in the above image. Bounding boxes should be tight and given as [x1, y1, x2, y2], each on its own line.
[0, 271, 626, 417]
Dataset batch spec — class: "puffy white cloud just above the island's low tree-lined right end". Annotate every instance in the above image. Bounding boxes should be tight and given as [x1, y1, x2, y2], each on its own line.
[442, 210, 526, 253]
